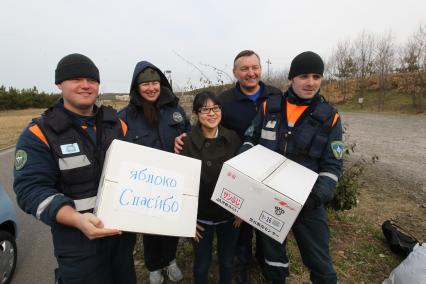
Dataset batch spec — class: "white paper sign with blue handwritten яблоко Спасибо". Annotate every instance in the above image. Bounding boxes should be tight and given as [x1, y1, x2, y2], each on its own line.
[113, 162, 184, 218]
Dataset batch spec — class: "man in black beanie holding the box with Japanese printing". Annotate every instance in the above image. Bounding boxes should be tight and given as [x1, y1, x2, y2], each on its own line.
[241, 51, 343, 284]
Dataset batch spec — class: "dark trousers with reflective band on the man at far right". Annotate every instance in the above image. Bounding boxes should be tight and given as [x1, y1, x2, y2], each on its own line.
[262, 206, 337, 284]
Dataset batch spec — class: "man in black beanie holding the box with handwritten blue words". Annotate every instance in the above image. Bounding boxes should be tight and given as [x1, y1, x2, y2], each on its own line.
[13, 53, 136, 284]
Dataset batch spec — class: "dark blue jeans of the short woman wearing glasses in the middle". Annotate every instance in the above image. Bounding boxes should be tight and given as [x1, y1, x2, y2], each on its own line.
[193, 220, 239, 284]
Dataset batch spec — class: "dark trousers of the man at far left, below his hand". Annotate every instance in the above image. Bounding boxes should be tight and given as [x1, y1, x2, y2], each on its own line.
[52, 224, 136, 284]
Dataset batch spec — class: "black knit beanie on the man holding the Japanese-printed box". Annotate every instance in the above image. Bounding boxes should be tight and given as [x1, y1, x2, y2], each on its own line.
[288, 51, 324, 80]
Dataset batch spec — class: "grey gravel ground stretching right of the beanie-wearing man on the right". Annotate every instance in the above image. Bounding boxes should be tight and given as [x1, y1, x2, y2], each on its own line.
[341, 113, 426, 202]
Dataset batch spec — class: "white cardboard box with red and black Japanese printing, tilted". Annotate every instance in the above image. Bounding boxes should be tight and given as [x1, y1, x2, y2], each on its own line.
[211, 145, 318, 243]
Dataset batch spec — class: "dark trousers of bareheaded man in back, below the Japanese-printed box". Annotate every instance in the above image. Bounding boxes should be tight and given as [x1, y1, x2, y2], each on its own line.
[235, 222, 264, 274]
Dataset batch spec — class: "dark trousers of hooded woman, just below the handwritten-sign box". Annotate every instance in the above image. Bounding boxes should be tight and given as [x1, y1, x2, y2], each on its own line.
[143, 234, 179, 271]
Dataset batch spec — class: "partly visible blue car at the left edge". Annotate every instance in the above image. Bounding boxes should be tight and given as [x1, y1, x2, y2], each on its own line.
[0, 184, 18, 284]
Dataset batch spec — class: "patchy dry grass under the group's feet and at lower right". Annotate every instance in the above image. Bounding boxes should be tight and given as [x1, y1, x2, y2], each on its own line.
[135, 163, 426, 284]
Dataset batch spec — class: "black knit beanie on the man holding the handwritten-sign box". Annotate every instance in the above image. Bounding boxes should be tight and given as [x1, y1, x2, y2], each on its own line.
[55, 53, 100, 84]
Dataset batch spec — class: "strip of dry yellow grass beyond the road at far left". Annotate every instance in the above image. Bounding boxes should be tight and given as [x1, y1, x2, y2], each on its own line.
[0, 109, 44, 149]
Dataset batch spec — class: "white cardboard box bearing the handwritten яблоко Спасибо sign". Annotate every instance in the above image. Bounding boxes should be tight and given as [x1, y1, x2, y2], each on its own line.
[95, 140, 201, 237]
